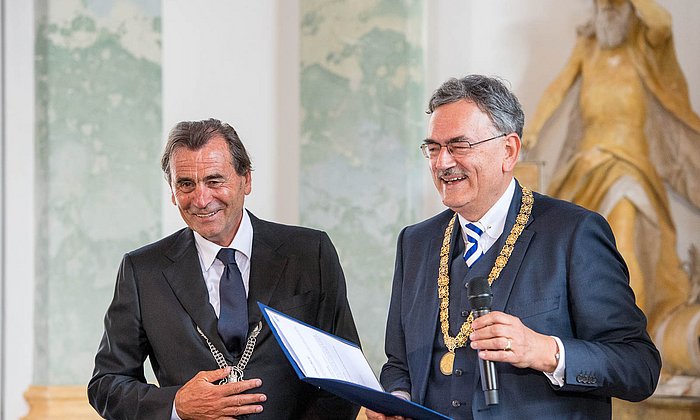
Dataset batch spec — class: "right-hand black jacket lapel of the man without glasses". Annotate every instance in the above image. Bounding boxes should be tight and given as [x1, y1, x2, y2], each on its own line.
[248, 213, 288, 325]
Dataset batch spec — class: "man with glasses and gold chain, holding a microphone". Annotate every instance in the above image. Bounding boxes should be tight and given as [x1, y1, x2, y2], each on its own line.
[368, 75, 661, 419]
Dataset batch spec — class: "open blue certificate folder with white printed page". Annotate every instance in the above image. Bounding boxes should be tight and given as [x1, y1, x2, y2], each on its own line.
[258, 302, 449, 420]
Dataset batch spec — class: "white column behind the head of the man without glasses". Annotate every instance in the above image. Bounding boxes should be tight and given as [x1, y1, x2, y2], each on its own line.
[163, 0, 299, 233]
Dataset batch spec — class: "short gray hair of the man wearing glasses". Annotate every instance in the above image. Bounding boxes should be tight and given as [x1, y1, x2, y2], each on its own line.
[426, 74, 525, 137]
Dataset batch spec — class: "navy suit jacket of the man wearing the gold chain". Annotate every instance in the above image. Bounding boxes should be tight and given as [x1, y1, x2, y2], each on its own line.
[381, 184, 661, 419]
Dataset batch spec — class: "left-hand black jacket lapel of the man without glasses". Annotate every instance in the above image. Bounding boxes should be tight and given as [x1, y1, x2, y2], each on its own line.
[163, 228, 228, 355]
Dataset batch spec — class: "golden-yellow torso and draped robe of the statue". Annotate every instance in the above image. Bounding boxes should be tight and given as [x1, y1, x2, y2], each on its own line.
[525, 18, 700, 369]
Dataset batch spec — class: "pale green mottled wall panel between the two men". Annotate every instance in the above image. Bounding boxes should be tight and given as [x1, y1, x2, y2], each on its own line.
[300, 0, 425, 371]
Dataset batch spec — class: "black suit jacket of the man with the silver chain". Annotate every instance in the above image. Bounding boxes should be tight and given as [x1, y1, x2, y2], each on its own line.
[88, 214, 359, 420]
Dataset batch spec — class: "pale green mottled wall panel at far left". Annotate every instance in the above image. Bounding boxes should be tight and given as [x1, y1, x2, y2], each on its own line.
[33, 0, 162, 385]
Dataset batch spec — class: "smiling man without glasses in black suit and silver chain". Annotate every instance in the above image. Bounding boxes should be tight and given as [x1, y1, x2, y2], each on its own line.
[88, 119, 359, 419]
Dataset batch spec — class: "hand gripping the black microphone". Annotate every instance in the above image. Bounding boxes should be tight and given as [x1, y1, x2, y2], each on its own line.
[469, 312, 557, 373]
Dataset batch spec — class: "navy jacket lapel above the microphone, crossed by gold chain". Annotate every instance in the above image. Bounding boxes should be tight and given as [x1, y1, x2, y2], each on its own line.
[492, 181, 537, 311]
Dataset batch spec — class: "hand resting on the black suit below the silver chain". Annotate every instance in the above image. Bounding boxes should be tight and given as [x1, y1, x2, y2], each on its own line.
[175, 367, 267, 420]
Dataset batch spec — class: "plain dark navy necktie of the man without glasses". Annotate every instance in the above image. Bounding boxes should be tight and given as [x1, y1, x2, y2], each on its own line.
[216, 248, 248, 354]
